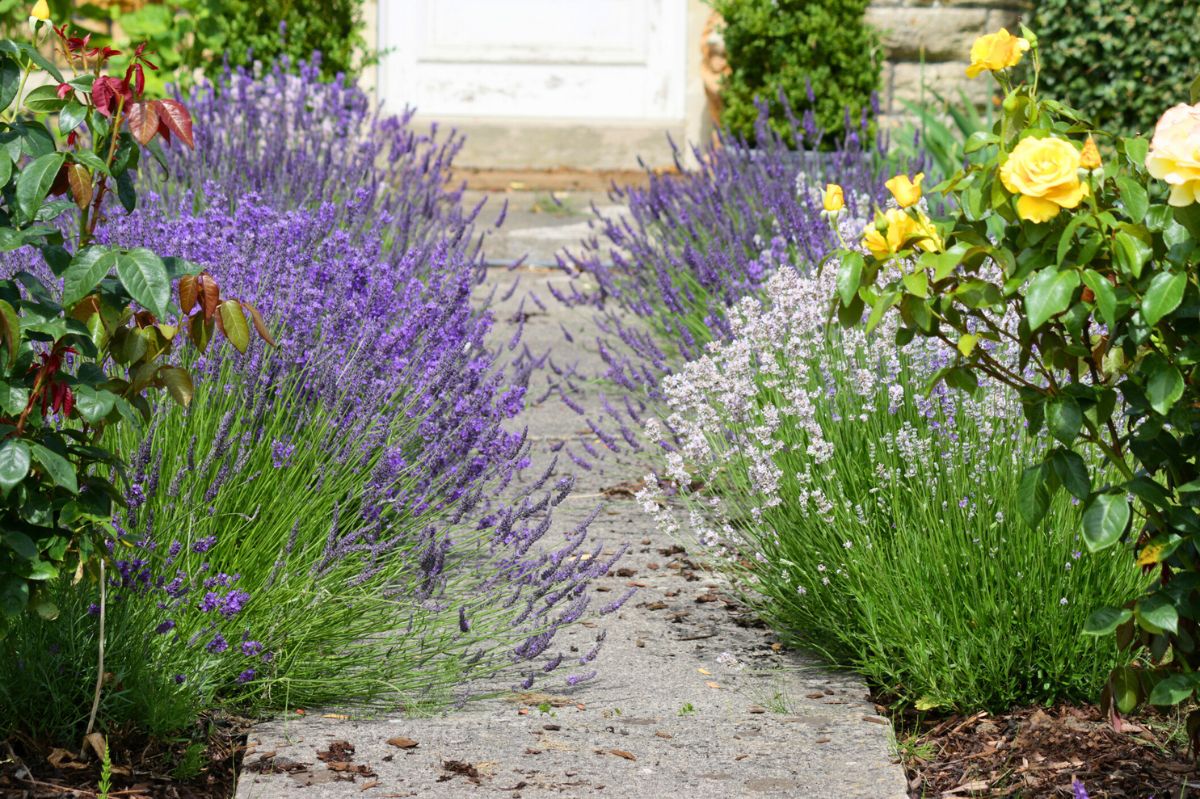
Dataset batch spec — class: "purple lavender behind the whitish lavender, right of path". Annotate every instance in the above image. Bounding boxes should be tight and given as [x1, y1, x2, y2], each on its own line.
[559, 102, 902, 410]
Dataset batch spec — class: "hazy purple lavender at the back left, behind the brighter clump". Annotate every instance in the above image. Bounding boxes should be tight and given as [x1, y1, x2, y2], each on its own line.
[146, 60, 474, 257]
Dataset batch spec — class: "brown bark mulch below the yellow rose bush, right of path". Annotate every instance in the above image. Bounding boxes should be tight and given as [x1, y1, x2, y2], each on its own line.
[896, 705, 1200, 799]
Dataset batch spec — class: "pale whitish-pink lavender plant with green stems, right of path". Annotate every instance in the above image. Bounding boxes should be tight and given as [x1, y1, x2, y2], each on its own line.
[641, 262, 1145, 709]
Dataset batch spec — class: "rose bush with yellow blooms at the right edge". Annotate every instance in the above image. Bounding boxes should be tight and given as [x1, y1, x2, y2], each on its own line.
[834, 28, 1200, 741]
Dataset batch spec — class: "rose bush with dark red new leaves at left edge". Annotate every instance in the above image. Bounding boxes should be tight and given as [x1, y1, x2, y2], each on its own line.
[0, 10, 270, 625]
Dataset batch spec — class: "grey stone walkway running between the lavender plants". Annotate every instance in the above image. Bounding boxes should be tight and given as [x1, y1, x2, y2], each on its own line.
[238, 196, 906, 799]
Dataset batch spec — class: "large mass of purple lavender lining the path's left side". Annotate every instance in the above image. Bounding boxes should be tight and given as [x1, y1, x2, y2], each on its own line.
[0, 49, 620, 748]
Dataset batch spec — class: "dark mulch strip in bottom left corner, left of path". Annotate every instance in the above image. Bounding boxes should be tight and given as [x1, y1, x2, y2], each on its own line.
[0, 716, 250, 799]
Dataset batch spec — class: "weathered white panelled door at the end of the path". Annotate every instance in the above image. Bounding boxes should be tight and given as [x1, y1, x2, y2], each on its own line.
[379, 0, 686, 121]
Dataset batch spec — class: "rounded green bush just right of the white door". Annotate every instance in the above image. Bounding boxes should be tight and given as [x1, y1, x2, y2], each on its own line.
[713, 0, 882, 144]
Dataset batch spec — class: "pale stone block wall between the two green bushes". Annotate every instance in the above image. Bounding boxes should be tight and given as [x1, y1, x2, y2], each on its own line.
[866, 0, 1031, 120]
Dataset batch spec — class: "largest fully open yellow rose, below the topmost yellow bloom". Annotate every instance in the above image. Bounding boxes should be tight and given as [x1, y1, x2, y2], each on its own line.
[1000, 137, 1087, 222]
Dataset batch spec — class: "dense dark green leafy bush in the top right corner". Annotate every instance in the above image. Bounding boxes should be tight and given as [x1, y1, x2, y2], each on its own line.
[1030, 0, 1200, 136]
